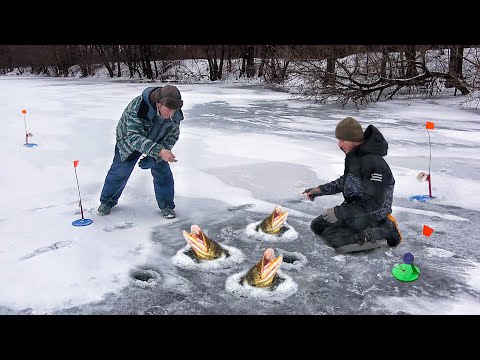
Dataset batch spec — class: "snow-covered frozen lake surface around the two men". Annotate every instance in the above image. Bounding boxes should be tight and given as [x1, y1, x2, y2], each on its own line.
[0, 76, 480, 314]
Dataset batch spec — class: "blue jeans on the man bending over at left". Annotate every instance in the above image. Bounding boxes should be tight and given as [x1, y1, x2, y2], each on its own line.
[100, 145, 175, 209]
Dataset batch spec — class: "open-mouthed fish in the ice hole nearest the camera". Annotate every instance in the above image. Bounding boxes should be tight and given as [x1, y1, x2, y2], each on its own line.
[243, 248, 283, 287]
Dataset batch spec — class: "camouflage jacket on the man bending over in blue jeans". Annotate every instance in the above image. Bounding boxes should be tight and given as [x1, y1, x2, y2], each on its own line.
[116, 86, 183, 161]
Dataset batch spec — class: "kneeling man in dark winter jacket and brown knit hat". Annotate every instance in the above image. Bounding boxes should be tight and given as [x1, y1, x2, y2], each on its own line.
[303, 117, 402, 253]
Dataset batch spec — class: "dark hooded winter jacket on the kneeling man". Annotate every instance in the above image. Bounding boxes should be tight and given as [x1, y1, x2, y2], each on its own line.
[319, 125, 395, 221]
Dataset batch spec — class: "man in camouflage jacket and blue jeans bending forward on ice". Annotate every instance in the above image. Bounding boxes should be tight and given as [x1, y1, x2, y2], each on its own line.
[97, 85, 183, 219]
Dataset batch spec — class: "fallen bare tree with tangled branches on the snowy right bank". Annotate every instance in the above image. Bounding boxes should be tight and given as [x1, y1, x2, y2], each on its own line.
[288, 45, 469, 106]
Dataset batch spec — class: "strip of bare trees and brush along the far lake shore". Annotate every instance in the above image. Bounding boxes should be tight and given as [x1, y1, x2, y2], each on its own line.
[0, 45, 480, 106]
